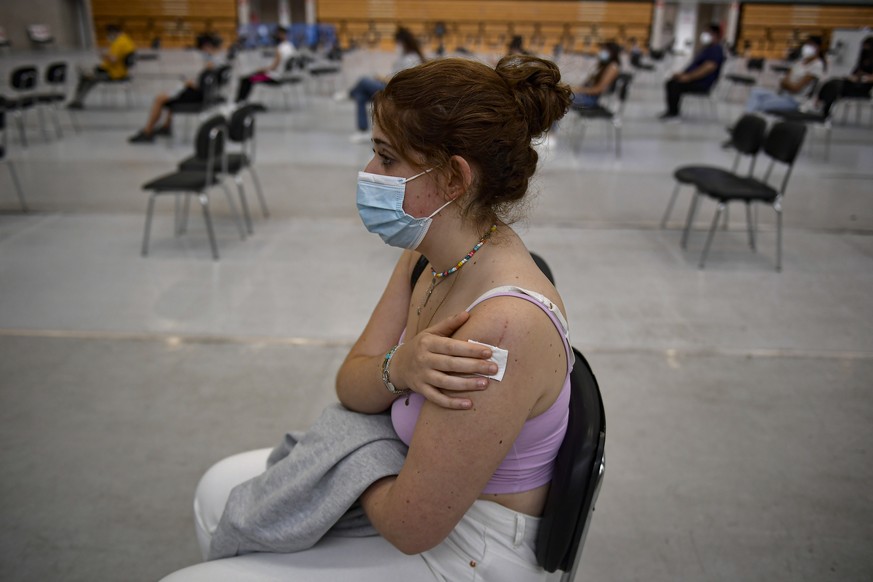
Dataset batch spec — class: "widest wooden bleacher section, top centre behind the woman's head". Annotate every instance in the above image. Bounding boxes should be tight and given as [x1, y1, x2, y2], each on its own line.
[316, 0, 653, 53]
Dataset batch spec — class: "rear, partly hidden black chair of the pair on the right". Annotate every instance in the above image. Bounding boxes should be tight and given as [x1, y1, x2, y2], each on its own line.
[661, 114, 767, 230]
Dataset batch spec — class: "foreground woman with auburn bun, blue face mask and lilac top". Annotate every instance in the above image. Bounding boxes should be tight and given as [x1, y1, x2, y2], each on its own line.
[186, 55, 573, 582]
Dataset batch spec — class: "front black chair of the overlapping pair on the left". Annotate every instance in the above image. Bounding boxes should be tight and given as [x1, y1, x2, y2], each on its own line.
[142, 115, 246, 261]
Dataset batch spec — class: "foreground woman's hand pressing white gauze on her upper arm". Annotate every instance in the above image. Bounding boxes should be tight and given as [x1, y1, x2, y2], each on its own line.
[391, 311, 497, 410]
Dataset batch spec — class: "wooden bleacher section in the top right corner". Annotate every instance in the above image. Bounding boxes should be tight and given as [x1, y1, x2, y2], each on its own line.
[737, 4, 873, 59]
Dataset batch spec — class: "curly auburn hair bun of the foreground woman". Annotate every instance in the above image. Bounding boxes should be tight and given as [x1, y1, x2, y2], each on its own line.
[495, 55, 572, 138]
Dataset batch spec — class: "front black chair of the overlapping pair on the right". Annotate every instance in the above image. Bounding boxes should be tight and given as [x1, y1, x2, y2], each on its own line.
[682, 121, 806, 271]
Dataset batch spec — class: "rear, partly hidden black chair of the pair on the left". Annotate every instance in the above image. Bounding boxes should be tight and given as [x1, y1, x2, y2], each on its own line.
[179, 104, 270, 234]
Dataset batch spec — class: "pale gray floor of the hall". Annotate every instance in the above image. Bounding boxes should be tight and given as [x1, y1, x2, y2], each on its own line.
[0, 46, 873, 582]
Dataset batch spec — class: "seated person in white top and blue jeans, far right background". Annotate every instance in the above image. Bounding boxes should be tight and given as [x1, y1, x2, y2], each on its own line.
[746, 36, 825, 113]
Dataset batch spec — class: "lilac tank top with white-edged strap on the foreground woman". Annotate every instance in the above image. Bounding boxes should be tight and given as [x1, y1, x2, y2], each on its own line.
[391, 287, 573, 493]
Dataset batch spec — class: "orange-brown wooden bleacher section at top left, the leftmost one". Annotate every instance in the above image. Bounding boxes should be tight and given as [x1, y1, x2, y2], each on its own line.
[91, 0, 237, 48]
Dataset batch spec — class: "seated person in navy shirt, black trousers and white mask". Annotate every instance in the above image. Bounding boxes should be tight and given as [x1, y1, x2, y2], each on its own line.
[659, 24, 725, 121]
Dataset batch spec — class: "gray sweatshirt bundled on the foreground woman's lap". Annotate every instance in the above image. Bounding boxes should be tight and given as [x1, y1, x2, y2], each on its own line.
[209, 404, 407, 560]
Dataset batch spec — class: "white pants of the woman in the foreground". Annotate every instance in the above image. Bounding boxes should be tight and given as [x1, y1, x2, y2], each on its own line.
[165, 449, 547, 582]
